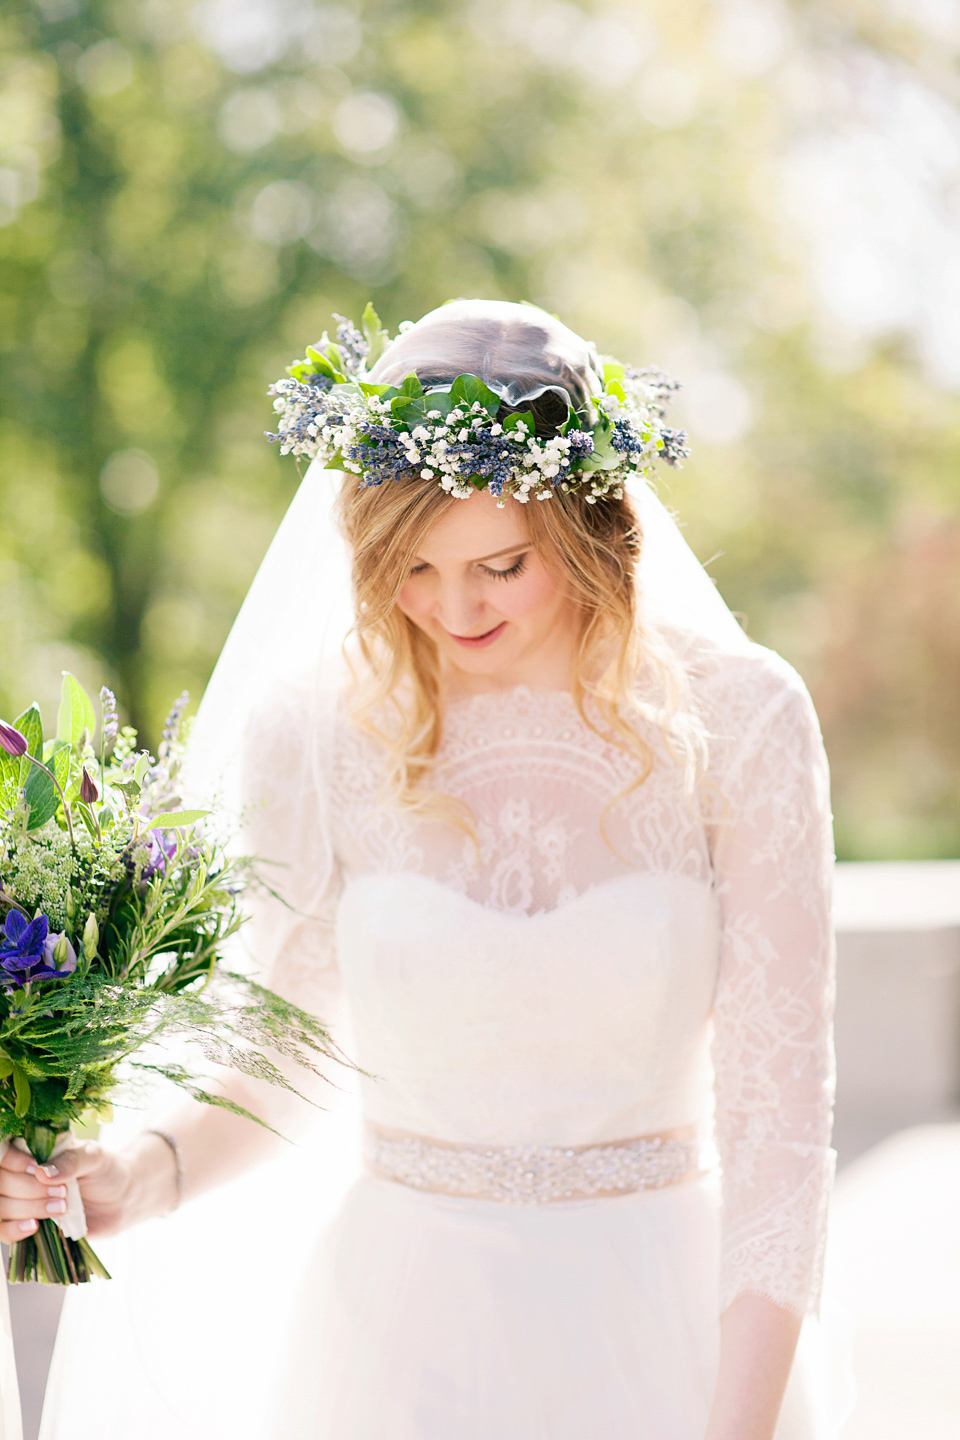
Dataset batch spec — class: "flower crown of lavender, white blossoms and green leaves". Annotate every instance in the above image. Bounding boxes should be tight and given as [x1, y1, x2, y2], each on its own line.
[266, 305, 689, 505]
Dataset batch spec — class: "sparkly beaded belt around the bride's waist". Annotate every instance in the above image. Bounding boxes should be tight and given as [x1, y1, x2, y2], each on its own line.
[366, 1125, 701, 1205]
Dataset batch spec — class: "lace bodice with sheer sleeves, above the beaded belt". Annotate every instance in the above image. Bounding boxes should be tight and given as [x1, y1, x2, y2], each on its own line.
[248, 648, 833, 1312]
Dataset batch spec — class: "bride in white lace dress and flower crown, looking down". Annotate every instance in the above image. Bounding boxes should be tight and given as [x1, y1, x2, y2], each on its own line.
[0, 301, 833, 1440]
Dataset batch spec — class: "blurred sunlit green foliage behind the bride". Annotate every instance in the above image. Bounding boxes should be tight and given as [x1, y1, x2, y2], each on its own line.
[0, 0, 960, 858]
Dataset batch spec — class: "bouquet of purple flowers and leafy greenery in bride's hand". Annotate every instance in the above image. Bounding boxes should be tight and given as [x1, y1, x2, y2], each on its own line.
[0, 674, 335, 1284]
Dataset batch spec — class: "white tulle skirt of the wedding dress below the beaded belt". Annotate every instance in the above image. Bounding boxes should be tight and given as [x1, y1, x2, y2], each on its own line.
[271, 1176, 835, 1440]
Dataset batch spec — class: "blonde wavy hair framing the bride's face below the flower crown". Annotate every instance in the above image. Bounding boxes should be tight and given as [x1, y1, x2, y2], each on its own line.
[338, 475, 704, 828]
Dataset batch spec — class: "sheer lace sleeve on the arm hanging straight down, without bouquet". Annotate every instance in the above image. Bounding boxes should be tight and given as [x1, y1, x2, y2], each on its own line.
[714, 667, 835, 1315]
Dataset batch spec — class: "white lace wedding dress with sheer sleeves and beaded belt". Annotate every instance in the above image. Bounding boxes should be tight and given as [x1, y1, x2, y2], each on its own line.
[238, 633, 833, 1440]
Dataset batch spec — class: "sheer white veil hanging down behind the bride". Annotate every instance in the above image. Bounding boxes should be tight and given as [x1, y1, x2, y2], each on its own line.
[40, 300, 846, 1440]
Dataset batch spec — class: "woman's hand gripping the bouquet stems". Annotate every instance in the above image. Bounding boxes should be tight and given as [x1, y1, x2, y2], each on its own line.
[0, 1135, 177, 1244]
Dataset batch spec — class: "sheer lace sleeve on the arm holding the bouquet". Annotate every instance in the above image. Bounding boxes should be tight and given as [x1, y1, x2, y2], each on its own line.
[242, 696, 341, 1024]
